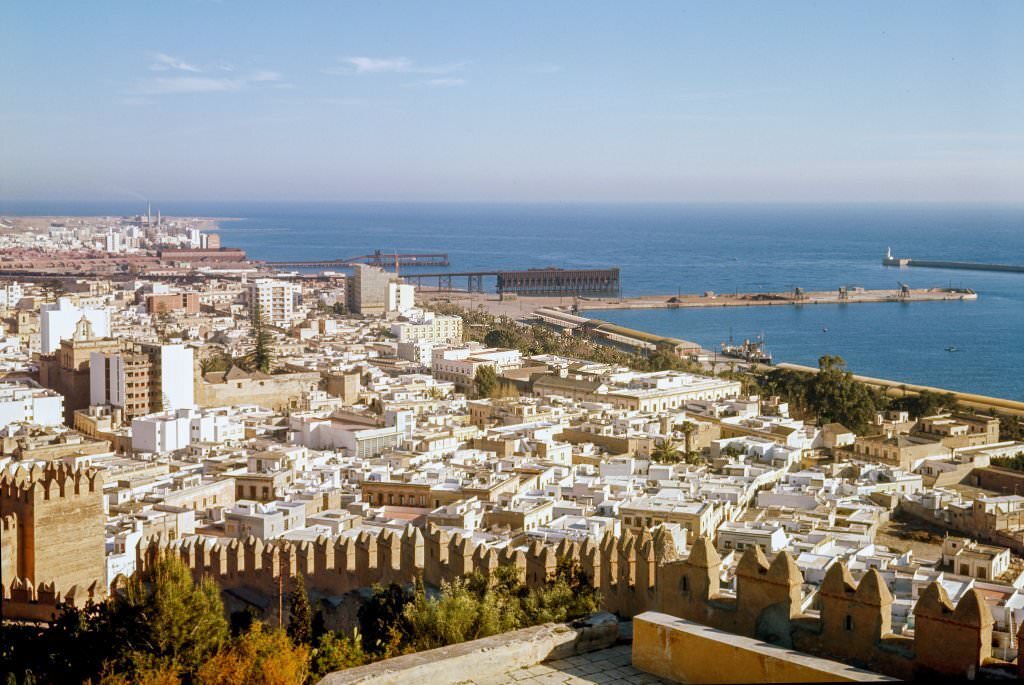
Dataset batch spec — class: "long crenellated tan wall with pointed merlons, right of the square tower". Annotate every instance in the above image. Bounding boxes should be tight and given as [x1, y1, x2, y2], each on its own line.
[128, 526, 1015, 678]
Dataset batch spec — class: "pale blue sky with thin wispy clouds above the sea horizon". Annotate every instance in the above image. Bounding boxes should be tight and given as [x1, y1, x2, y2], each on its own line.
[0, 0, 1024, 202]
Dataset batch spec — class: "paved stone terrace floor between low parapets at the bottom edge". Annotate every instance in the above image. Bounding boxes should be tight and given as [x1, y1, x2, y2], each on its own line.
[462, 645, 671, 685]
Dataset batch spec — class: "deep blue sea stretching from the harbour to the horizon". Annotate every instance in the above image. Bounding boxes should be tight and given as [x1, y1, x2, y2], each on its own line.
[0, 202, 1024, 400]
